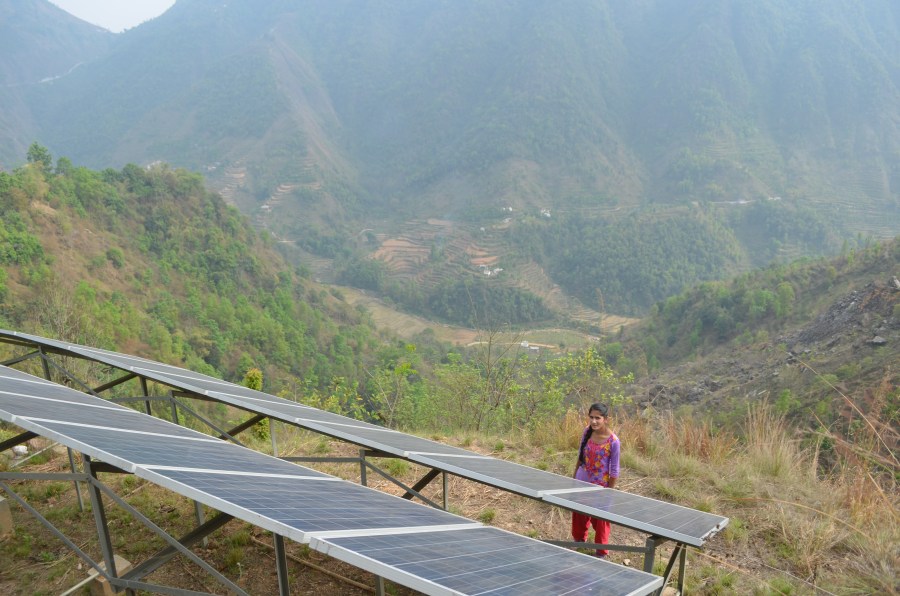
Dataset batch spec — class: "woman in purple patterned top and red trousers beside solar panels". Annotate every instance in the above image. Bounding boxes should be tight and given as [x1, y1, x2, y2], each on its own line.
[572, 404, 619, 559]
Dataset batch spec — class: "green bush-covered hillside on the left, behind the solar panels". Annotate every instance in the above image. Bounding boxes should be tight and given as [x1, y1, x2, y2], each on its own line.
[0, 146, 381, 397]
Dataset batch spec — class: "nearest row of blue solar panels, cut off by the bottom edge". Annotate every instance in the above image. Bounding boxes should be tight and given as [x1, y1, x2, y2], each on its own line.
[0, 366, 662, 595]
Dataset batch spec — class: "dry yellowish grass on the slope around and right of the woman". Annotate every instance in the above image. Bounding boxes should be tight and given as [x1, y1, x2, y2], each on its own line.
[520, 394, 900, 594]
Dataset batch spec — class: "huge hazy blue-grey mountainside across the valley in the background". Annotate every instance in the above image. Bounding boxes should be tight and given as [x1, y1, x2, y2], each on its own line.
[0, 0, 900, 322]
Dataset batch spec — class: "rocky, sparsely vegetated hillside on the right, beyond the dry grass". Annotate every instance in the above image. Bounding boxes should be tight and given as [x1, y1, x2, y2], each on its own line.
[617, 238, 900, 442]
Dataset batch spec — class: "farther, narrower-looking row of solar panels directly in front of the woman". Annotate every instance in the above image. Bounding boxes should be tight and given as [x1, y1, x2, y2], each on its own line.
[0, 330, 728, 547]
